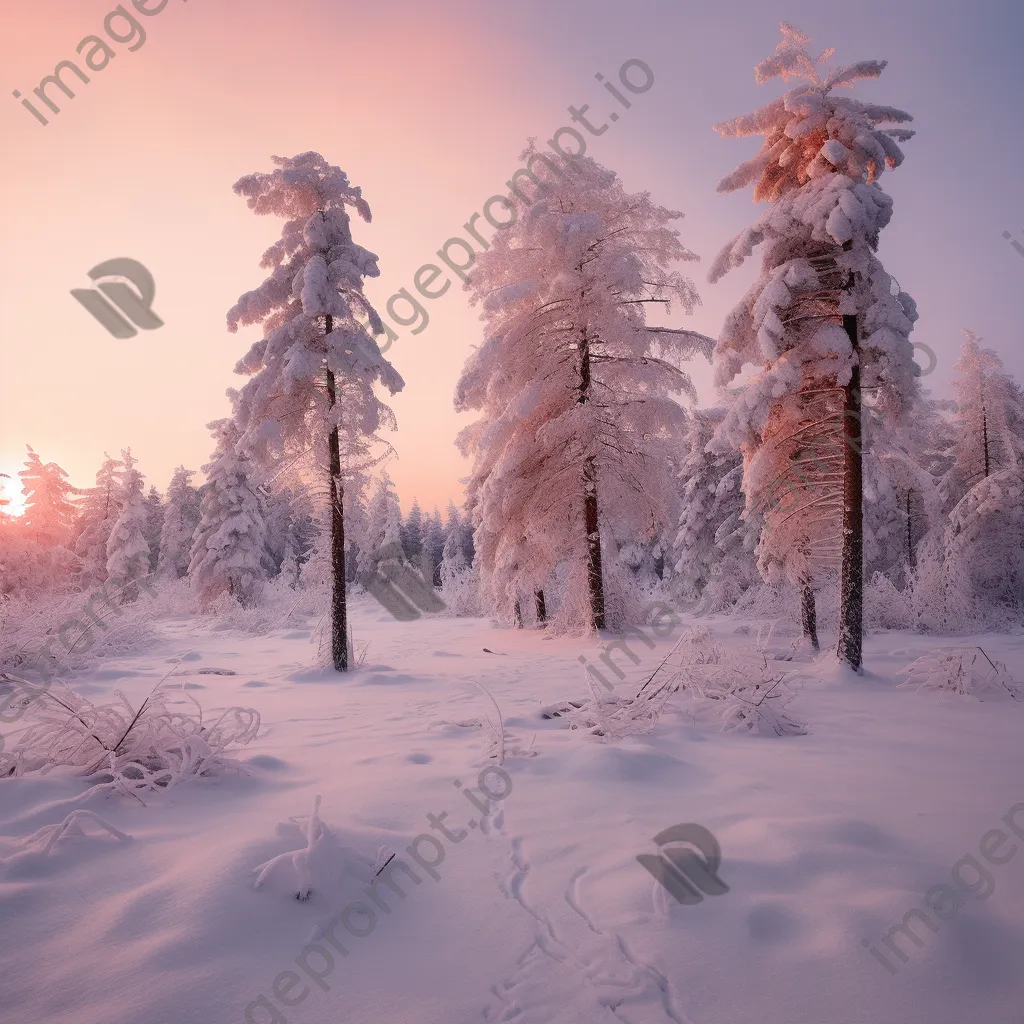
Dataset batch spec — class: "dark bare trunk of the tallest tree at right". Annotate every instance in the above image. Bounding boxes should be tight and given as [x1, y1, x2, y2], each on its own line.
[837, 314, 864, 672]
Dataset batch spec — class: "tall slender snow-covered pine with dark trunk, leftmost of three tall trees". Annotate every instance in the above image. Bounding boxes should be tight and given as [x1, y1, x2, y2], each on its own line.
[227, 152, 404, 672]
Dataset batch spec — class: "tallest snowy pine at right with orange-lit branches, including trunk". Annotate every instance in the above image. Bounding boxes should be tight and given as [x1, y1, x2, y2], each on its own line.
[709, 23, 916, 669]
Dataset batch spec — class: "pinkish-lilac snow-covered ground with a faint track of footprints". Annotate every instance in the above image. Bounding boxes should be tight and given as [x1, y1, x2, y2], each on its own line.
[0, 599, 1024, 1024]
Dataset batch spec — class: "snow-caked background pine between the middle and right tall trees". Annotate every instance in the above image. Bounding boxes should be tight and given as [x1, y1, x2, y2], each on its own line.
[671, 409, 757, 612]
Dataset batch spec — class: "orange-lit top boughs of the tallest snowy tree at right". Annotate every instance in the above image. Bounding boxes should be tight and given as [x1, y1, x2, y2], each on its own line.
[715, 22, 913, 203]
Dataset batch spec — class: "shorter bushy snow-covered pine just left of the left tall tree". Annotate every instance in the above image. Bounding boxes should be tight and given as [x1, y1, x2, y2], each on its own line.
[188, 419, 273, 607]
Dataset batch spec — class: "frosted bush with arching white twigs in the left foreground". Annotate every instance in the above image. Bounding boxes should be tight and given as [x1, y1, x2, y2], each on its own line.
[0, 680, 260, 803]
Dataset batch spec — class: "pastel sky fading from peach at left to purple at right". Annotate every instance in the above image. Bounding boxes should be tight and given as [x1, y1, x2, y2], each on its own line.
[0, 0, 1024, 508]
